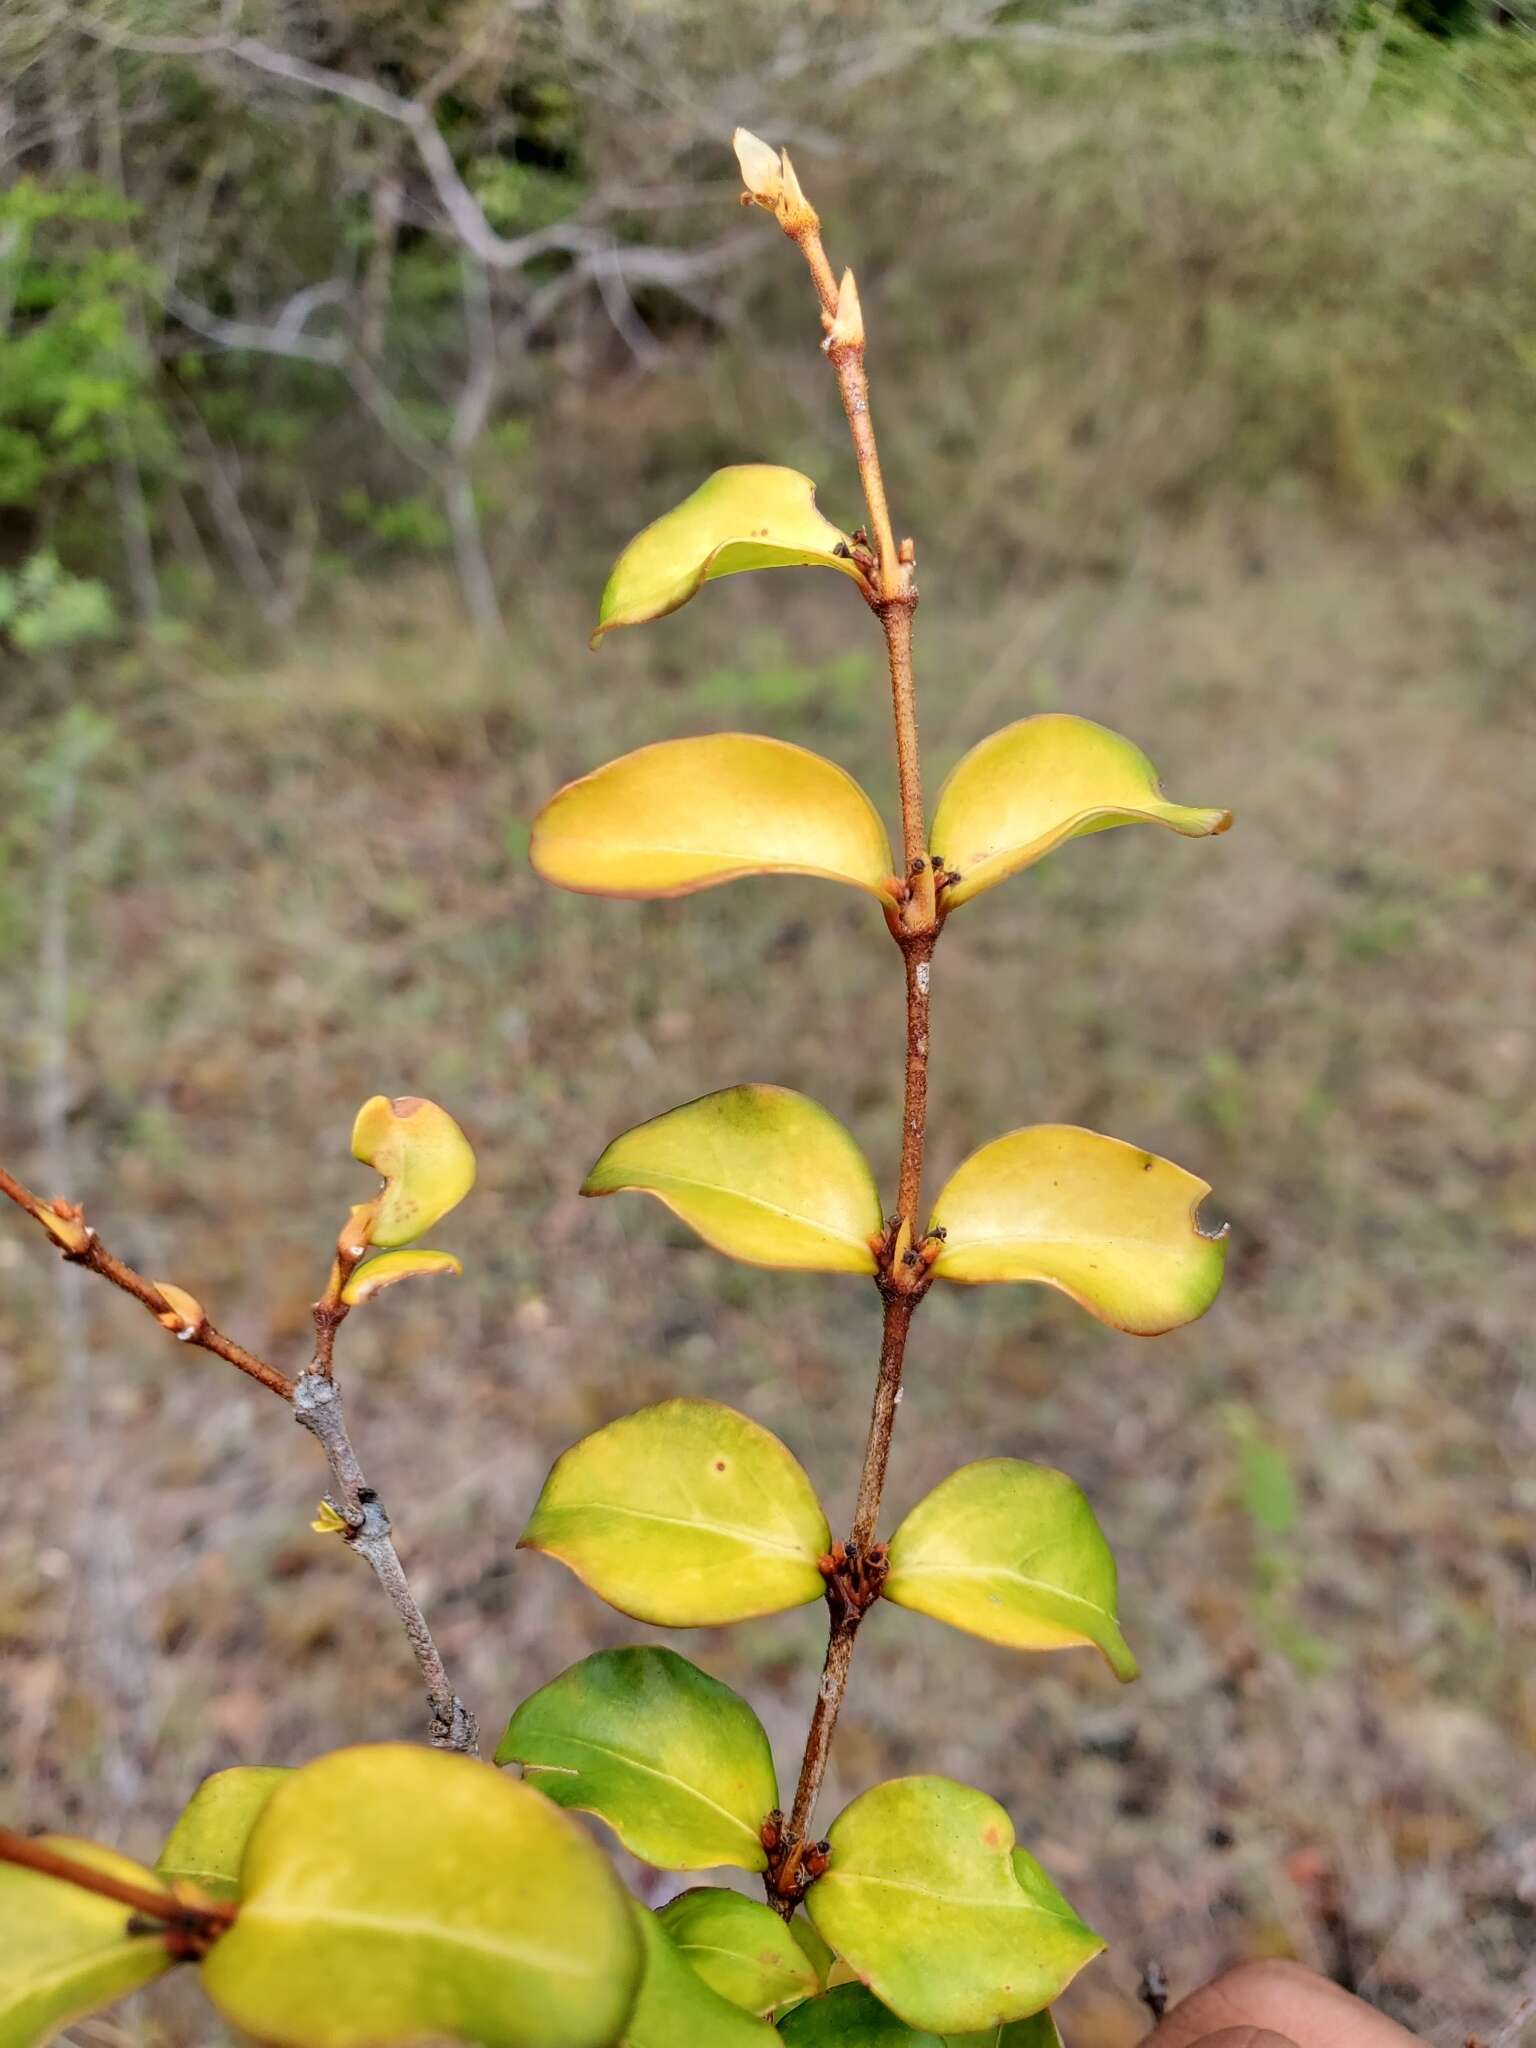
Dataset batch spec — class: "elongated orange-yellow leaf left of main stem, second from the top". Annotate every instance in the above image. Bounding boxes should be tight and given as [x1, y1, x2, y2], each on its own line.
[530, 733, 895, 901]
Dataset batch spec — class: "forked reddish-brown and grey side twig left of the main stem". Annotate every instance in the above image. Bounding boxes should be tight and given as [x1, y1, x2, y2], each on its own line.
[0, 1167, 479, 1757]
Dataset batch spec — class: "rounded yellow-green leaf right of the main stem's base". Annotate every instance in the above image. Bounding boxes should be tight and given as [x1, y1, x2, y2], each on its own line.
[807, 1778, 1104, 2034]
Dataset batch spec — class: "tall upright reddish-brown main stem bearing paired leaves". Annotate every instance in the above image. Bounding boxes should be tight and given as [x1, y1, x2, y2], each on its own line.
[768, 184, 942, 1919]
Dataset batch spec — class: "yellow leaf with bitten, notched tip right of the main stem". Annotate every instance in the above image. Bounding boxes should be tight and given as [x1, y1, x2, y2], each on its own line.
[932, 1124, 1227, 1337]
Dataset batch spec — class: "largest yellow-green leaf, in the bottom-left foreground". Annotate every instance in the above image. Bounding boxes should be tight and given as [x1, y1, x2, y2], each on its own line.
[203, 1743, 641, 2048]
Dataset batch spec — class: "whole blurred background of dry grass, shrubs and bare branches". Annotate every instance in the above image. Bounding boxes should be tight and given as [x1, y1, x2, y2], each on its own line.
[0, 0, 1536, 2048]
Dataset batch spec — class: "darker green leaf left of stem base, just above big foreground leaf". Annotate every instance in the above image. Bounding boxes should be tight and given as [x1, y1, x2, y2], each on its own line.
[496, 1649, 778, 1875]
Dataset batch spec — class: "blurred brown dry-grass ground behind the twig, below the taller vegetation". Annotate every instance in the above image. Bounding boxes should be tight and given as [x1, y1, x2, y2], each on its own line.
[0, 499, 1536, 2044]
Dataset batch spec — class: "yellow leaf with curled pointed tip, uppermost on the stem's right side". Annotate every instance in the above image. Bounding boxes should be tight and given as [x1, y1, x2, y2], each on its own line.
[930, 711, 1233, 909]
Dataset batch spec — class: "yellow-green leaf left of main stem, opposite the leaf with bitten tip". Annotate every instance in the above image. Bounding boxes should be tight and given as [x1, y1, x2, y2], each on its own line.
[582, 1083, 883, 1274]
